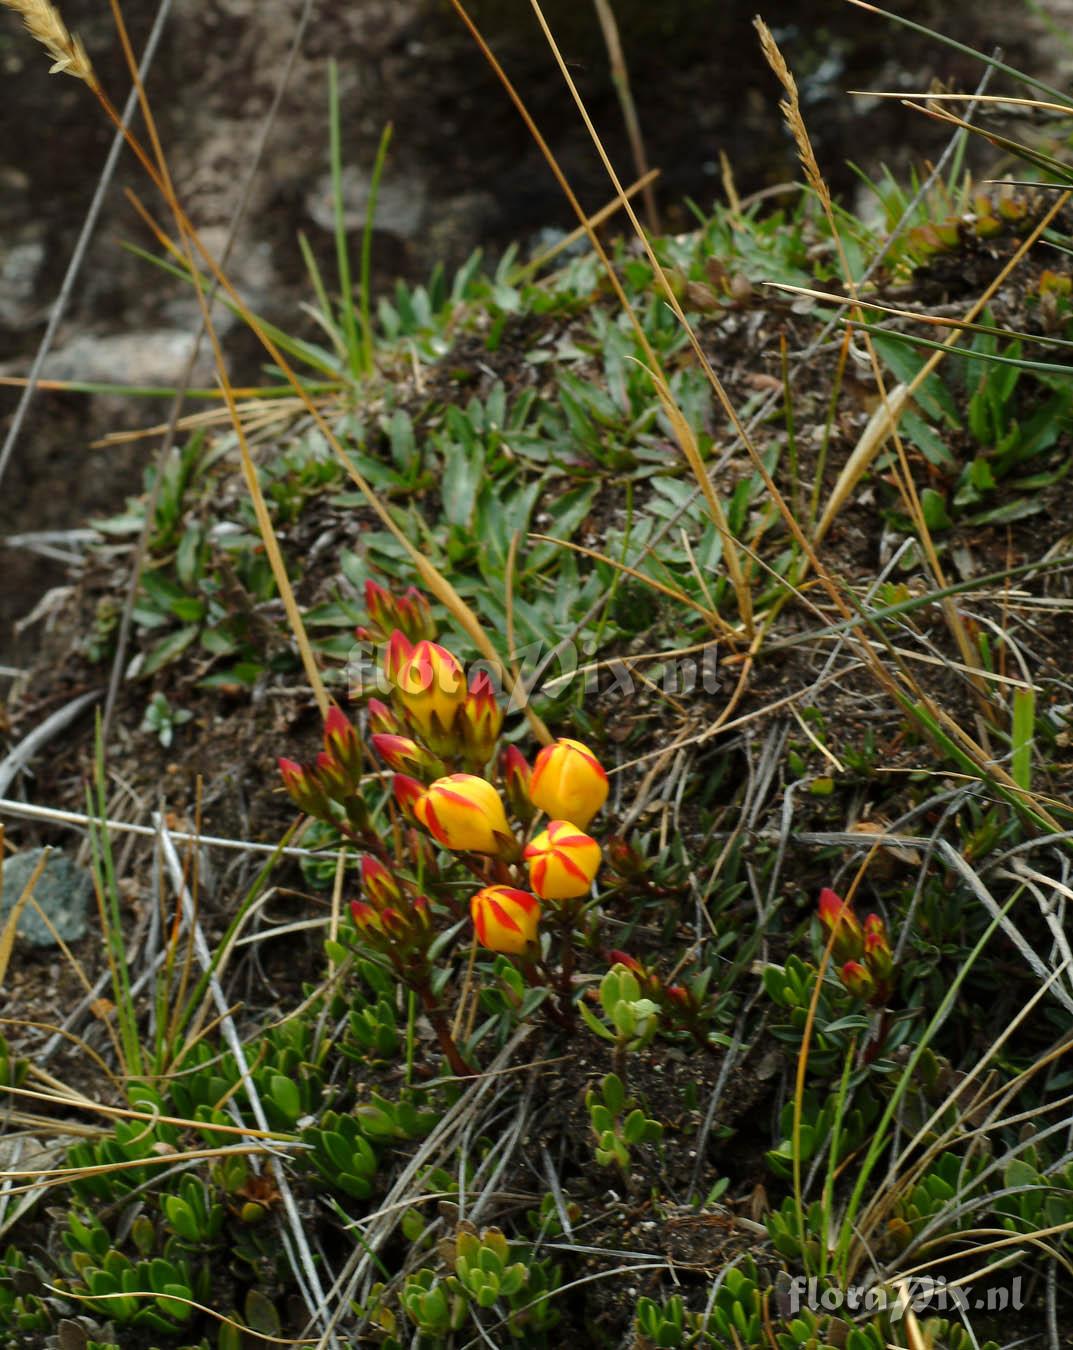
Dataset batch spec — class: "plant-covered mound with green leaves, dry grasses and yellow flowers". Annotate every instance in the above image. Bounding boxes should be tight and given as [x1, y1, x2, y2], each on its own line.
[0, 4, 1073, 1350]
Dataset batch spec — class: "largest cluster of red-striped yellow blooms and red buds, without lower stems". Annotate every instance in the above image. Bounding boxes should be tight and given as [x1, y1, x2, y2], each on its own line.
[279, 582, 607, 973]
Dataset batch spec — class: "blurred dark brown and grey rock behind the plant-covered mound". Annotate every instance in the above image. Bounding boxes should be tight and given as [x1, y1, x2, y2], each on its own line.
[0, 0, 1066, 666]
